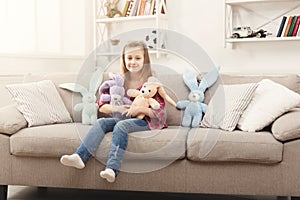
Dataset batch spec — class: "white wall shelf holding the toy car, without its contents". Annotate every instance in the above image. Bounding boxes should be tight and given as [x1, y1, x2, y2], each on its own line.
[224, 0, 300, 47]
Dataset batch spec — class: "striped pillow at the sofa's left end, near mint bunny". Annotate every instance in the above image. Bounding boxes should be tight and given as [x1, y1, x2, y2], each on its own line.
[6, 80, 72, 127]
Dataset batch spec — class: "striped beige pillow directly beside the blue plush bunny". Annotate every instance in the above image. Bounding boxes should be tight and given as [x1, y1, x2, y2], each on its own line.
[201, 83, 257, 131]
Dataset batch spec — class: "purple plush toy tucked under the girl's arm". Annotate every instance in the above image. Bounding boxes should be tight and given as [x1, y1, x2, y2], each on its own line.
[99, 73, 132, 119]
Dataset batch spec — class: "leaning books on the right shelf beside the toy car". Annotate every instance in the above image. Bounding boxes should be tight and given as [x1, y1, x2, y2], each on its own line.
[277, 15, 300, 37]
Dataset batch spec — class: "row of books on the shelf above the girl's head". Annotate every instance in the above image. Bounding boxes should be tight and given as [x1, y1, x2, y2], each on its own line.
[122, 0, 164, 17]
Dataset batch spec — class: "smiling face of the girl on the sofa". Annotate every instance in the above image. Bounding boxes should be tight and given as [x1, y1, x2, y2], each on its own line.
[125, 48, 144, 73]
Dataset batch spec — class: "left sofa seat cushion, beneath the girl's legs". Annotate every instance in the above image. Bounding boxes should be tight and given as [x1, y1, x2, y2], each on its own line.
[10, 123, 189, 160]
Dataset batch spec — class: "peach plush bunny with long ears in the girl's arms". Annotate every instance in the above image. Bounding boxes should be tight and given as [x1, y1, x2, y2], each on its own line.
[127, 77, 176, 119]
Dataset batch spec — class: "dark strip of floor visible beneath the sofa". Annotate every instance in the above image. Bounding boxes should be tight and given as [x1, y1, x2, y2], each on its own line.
[8, 186, 284, 200]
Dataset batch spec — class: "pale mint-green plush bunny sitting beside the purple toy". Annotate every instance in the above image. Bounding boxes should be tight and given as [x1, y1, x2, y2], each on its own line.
[59, 68, 103, 124]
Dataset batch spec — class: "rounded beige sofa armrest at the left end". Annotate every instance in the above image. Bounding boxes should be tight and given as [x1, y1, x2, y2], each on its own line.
[0, 104, 27, 135]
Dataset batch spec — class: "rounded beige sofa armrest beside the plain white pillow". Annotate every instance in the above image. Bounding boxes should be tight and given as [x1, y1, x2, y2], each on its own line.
[271, 108, 300, 142]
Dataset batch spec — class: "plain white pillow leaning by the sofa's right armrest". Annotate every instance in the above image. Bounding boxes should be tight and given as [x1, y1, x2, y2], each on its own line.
[238, 79, 300, 132]
